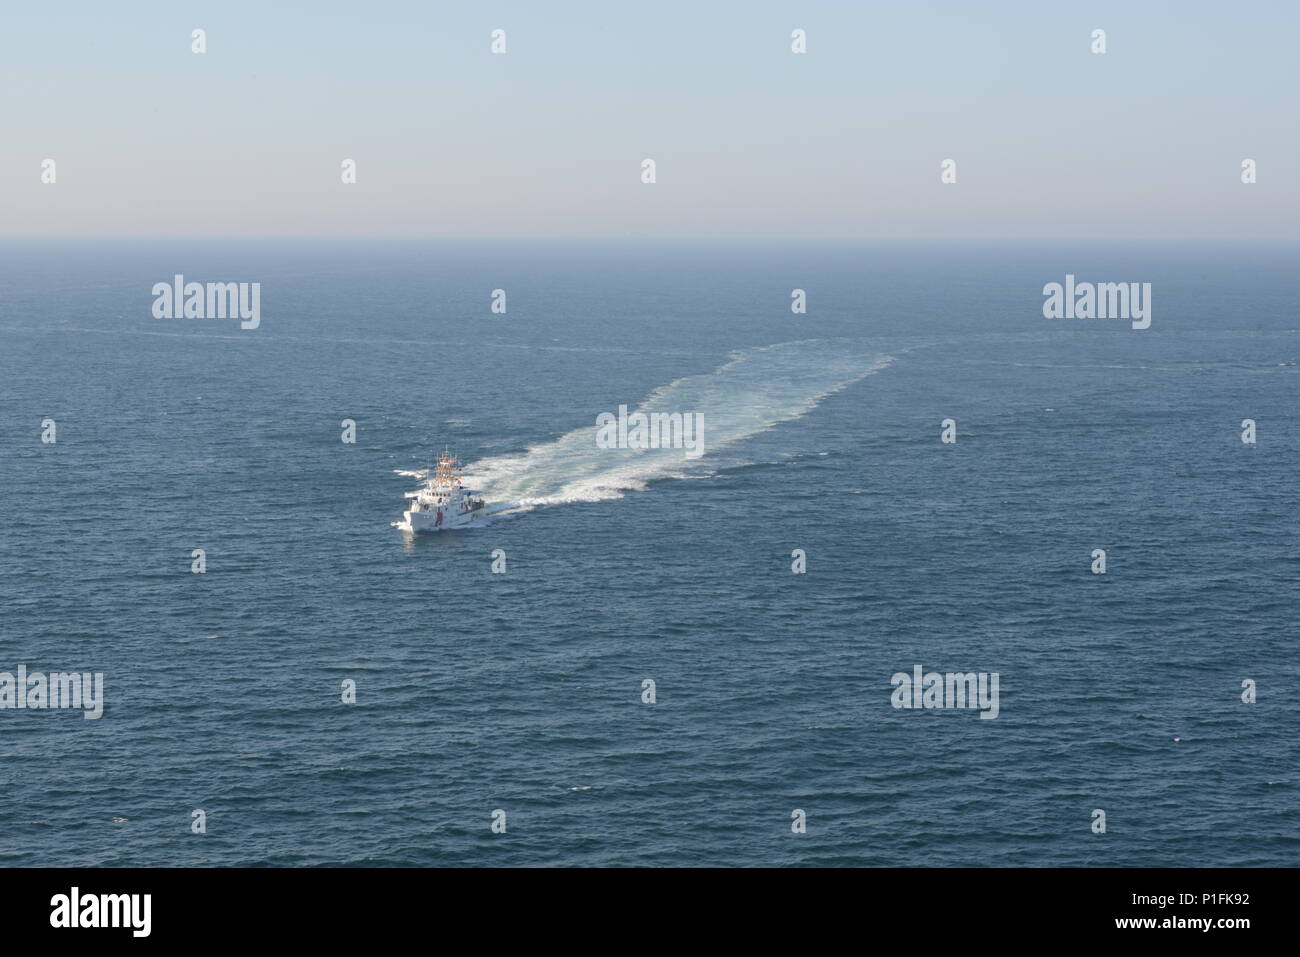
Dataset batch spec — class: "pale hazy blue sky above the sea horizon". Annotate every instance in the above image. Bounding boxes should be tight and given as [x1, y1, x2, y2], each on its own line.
[0, 0, 1300, 239]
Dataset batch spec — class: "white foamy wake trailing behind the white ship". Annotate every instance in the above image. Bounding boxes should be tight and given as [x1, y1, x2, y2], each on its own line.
[465, 339, 893, 512]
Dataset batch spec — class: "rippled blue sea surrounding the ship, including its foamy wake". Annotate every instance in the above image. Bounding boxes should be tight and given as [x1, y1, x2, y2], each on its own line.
[0, 241, 1300, 866]
